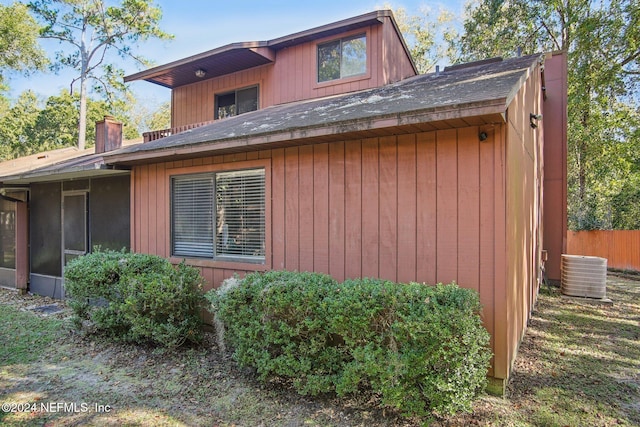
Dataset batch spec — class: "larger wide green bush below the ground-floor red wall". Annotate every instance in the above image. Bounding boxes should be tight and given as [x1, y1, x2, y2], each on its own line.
[207, 271, 491, 415]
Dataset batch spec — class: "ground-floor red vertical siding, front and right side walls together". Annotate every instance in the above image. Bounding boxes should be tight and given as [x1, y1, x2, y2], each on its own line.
[132, 57, 546, 379]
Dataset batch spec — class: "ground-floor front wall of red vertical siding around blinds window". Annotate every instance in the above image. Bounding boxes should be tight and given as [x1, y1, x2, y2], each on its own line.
[132, 125, 506, 375]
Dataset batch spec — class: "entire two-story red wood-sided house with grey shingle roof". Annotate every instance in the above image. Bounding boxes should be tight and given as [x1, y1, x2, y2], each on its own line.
[0, 11, 566, 387]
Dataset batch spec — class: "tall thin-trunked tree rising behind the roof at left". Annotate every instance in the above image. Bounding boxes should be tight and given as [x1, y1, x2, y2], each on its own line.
[29, 0, 171, 149]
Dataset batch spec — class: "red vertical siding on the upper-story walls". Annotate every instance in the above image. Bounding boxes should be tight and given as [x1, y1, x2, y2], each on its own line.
[171, 17, 415, 127]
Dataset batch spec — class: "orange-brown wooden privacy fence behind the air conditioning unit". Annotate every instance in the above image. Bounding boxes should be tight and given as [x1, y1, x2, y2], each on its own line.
[567, 230, 640, 271]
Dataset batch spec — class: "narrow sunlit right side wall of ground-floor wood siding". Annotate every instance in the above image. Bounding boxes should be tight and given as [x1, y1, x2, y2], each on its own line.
[502, 61, 543, 378]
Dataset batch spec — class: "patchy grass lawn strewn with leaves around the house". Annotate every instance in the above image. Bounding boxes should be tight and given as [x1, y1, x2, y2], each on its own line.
[0, 276, 640, 426]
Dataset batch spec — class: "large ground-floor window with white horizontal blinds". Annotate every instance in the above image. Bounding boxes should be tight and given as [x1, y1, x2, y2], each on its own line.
[171, 169, 265, 262]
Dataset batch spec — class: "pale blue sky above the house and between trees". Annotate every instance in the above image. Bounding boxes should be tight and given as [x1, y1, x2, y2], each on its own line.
[0, 0, 462, 105]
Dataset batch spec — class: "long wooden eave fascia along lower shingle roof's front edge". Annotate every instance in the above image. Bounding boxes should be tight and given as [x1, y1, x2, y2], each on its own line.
[106, 98, 507, 166]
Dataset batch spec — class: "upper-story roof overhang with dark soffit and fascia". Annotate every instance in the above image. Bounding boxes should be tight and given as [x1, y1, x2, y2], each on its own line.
[124, 10, 417, 89]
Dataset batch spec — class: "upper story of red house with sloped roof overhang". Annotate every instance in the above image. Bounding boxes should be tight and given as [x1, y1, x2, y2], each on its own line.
[125, 11, 417, 141]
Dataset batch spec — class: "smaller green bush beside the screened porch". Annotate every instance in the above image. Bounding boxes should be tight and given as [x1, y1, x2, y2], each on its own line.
[64, 250, 205, 347]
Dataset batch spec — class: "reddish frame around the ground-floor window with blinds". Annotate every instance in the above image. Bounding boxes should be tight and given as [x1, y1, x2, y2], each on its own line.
[166, 164, 271, 270]
